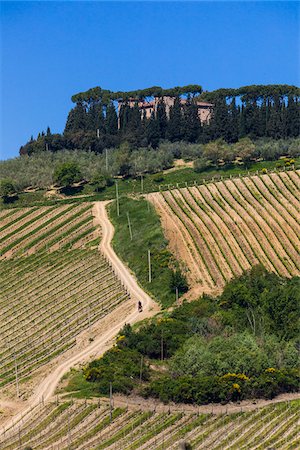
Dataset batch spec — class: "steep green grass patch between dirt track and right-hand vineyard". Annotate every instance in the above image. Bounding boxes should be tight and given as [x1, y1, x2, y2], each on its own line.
[109, 197, 175, 308]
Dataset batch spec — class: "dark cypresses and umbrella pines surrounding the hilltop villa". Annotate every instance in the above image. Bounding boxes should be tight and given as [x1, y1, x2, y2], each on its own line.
[20, 85, 300, 155]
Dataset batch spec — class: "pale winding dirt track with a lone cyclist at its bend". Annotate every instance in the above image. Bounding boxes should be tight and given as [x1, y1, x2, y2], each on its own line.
[0, 202, 159, 436]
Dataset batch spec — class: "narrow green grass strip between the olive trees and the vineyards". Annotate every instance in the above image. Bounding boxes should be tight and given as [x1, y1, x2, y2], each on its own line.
[0, 158, 300, 209]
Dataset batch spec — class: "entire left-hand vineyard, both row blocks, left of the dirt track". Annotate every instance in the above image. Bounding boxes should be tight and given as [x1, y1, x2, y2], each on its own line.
[0, 204, 128, 386]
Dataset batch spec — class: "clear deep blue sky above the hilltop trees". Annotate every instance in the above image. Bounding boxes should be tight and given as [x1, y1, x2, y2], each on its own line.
[0, 1, 299, 159]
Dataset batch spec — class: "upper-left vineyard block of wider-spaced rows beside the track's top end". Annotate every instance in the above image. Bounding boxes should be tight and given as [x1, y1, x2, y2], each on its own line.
[0, 203, 98, 259]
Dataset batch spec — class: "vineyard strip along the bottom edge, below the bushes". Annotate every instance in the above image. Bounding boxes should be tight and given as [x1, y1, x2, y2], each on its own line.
[0, 399, 300, 450]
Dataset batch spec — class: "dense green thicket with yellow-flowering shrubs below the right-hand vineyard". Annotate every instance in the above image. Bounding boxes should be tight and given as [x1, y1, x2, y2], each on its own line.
[85, 266, 300, 404]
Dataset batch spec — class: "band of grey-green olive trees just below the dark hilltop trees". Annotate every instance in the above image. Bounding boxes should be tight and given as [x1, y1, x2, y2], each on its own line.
[0, 138, 300, 191]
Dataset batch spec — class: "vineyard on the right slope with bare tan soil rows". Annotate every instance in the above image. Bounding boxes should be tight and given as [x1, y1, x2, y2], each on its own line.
[148, 171, 300, 295]
